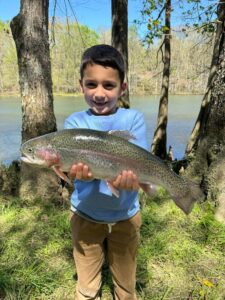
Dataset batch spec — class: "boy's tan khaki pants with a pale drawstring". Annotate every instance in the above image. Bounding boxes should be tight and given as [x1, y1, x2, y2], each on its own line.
[71, 212, 141, 300]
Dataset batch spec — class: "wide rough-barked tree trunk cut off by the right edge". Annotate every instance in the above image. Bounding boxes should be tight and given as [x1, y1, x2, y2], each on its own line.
[186, 2, 225, 222]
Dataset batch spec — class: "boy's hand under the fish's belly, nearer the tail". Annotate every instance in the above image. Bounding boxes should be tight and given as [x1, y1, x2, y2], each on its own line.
[110, 170, 140, 191]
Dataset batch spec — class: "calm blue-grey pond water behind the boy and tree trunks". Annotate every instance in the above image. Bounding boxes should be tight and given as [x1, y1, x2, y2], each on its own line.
[0, 95, 202, 164]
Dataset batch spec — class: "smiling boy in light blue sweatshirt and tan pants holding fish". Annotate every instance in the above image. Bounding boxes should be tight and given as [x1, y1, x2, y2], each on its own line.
[65, 45, 147, 300]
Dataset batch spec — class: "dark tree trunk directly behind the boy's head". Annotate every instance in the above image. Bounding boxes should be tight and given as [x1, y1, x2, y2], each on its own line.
[111, 0, 130, 108]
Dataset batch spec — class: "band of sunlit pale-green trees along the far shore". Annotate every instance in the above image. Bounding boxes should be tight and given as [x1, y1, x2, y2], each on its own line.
[0, 19, 212, 95]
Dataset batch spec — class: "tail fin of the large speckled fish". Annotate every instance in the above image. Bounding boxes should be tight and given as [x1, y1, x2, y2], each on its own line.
[173, 182, 205, 215]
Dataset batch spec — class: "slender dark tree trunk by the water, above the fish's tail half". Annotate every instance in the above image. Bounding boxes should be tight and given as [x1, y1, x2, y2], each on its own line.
[151, 0, 171, 159]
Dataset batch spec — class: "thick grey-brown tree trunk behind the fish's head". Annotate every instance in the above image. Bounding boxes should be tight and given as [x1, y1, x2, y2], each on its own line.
[10, 0, 59, 199]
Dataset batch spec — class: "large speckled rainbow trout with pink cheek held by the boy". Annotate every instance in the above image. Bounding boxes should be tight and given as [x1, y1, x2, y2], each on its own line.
[21, 129, 203, 214]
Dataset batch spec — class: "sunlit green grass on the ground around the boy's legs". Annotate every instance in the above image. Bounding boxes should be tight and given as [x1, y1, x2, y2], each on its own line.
[0, 192, 225, 300]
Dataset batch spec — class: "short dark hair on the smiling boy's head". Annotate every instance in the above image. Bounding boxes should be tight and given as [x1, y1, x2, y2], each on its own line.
[80, 44, 125, 83]
